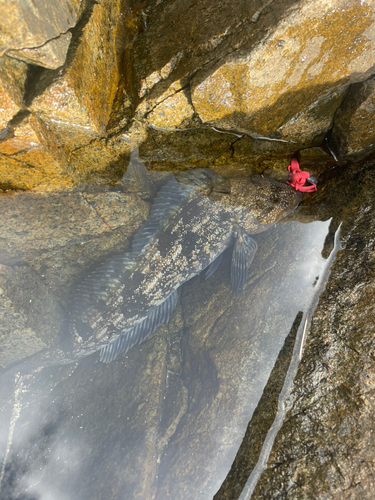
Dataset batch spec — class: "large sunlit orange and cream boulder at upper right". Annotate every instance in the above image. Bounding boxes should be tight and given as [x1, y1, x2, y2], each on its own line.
[192, 0, 375, 148]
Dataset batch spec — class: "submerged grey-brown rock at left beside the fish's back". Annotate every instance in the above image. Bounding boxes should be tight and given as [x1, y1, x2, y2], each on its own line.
[0, 187, 148, 366]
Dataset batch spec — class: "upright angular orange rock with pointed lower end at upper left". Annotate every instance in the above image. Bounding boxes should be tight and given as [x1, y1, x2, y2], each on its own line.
[30, 0, 123, 151]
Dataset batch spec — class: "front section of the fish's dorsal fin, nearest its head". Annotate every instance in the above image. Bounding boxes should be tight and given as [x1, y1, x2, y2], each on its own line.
[132, 174, 193, 253]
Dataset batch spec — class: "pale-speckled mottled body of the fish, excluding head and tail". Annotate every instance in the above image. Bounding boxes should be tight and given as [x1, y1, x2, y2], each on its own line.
[72, 179, 259, 358]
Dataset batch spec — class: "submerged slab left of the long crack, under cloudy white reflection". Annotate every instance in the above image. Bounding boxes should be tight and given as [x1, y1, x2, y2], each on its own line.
[0, 330, 168, 500]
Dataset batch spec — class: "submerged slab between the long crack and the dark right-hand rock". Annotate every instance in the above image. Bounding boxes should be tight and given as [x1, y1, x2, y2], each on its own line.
[155, 223, 334, 500]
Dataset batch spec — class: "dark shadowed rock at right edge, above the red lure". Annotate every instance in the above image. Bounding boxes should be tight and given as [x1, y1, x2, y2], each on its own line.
[330, 78, 375, 160]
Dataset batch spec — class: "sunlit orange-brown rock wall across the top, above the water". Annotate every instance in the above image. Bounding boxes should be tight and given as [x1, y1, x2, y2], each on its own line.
[0, 0, 375, 189]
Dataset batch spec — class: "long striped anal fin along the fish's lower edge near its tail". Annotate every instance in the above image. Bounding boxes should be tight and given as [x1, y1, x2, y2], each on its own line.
[100, 290, 178, 363]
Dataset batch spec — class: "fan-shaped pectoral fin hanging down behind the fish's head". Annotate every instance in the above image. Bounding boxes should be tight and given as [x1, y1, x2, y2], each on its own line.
[231, 229, 258, 292]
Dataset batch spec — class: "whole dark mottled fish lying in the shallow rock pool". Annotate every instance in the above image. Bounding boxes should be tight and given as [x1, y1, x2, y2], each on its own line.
[2, 150, 300, 374]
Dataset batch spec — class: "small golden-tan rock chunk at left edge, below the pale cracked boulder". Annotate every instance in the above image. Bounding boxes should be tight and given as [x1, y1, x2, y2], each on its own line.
[0, 56, 27, 130]
